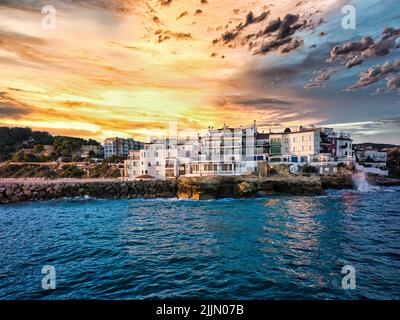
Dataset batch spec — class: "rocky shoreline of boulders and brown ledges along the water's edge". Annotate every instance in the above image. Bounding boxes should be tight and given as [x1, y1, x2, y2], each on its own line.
[0, 174, 400, 204]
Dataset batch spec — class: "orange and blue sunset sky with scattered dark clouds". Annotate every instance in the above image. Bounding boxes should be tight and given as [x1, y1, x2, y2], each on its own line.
[0, 0, 400, 144]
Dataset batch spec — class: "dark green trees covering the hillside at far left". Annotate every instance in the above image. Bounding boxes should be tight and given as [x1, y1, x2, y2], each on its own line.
[0, 127, 100, 161]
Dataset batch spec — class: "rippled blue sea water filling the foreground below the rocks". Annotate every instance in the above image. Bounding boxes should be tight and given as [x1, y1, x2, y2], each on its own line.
[0, 188, 400, 299]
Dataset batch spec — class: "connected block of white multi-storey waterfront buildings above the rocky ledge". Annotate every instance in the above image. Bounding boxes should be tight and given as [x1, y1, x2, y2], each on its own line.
[124, 122, 352, 179]
